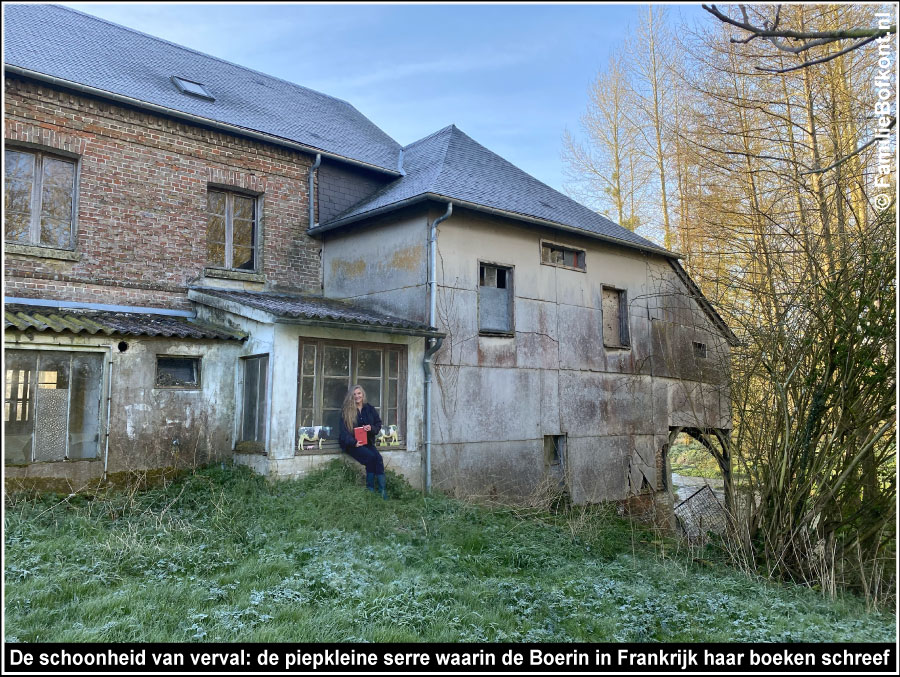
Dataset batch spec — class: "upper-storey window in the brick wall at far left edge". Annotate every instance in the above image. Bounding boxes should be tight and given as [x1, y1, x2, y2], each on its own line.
[3, 148, 76, 249]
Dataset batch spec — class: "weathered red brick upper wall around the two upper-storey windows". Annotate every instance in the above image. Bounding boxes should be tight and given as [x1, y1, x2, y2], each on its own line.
[4, 77, 321, 307]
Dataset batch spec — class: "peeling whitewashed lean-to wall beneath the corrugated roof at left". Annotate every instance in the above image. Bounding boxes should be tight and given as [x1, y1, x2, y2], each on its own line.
[5, 331, 241, 490]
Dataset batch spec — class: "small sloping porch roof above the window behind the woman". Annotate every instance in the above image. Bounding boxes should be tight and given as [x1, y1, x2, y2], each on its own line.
[188, 287, 443, 336]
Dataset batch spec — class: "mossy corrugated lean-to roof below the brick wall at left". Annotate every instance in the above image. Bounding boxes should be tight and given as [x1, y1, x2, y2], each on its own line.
[4, 303, 247, 341]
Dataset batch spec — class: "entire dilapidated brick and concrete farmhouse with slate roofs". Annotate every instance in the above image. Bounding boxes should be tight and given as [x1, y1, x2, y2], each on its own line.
[4, 5, 735, 516]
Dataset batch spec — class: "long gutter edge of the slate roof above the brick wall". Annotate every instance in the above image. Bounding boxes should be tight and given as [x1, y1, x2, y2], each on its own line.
[3, 64, 403, 177]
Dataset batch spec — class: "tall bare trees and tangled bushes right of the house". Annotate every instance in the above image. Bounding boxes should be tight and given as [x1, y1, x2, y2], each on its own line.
[567, 4, 897, 604]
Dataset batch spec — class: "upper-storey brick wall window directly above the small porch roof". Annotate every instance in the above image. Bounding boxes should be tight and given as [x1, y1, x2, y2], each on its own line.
[206, 188, 259, 272]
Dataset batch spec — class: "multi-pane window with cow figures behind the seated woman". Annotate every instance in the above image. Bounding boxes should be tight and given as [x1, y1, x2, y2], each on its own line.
[297, 338, 406, 450]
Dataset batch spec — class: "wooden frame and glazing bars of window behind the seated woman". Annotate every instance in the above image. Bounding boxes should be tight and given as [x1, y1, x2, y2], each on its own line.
[294, 336, 408, 454]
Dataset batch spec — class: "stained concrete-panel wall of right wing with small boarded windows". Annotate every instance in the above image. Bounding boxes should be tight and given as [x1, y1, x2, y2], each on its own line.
[433, 209, 731, 503]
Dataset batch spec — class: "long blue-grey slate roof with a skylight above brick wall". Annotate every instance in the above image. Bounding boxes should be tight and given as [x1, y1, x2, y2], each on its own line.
[3, 3, 400, 175]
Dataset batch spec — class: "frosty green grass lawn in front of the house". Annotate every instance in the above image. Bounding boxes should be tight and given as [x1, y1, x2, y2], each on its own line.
[5, 461, 894, 642]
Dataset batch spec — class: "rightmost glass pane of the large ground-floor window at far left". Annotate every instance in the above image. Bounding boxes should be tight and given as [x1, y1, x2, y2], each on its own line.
[69, 354, 103, 458]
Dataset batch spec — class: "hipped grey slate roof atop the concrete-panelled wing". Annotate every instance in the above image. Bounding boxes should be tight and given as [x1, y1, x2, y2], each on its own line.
[309, 125, 674, 256]
